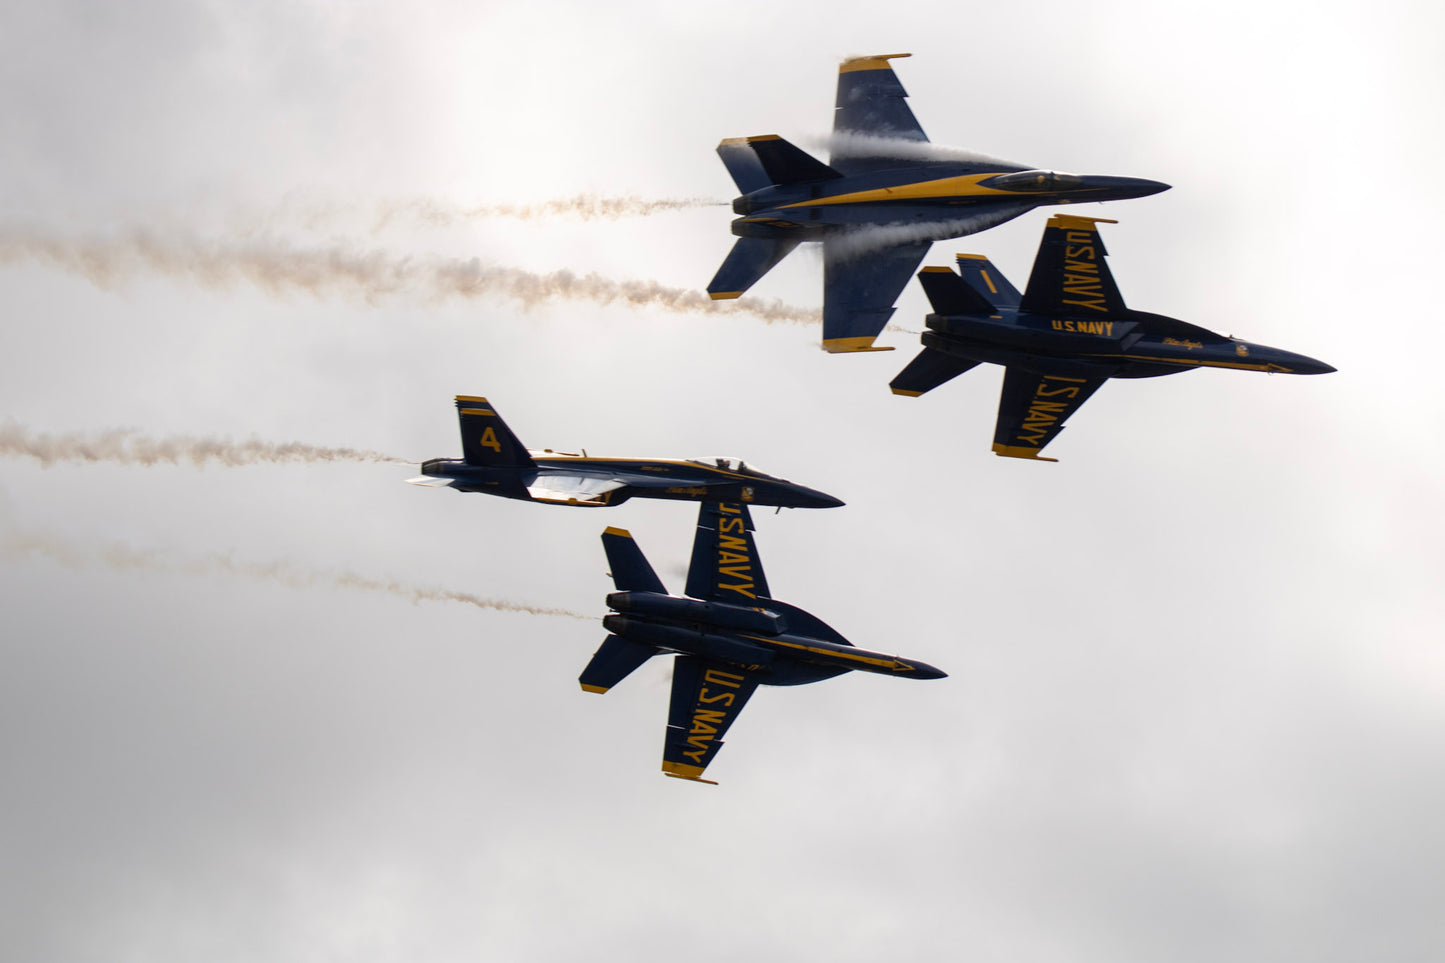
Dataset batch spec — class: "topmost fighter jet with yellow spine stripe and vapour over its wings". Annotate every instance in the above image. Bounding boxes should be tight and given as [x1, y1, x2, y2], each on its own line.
[708, 54, 1169, 351]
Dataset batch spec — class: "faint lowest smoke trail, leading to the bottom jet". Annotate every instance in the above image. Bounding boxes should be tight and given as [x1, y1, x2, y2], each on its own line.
[0, 531, 594, 622]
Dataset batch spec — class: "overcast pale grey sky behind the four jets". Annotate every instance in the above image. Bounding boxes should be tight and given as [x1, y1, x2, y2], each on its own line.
[0, 0, 1445, 963]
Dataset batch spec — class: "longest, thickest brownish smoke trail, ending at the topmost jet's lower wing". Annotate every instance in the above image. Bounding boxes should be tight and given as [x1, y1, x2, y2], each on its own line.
[0, 231, 819, 324]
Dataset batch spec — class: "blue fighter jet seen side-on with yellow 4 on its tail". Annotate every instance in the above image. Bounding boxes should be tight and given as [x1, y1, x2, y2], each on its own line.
[407, 395, 842, 508]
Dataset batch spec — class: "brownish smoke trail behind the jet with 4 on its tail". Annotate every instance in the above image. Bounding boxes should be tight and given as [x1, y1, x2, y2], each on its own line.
[0, 419, 415, 468]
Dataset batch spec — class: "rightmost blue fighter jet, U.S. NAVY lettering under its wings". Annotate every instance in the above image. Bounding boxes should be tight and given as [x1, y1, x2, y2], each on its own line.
[890, 214, 1335, 461]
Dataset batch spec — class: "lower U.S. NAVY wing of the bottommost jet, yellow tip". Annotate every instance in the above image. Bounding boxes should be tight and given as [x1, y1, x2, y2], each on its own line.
[662, 655, 759, 785]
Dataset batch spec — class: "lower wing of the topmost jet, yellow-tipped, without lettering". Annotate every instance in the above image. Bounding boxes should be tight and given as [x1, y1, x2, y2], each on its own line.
[822, 240, 932, 351]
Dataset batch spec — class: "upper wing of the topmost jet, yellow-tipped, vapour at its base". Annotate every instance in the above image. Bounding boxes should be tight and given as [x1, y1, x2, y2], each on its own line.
[828, 54, 928, 174]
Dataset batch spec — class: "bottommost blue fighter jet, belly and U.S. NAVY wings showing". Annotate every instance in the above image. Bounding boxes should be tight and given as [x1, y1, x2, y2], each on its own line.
[578, 502, 944, 785]
